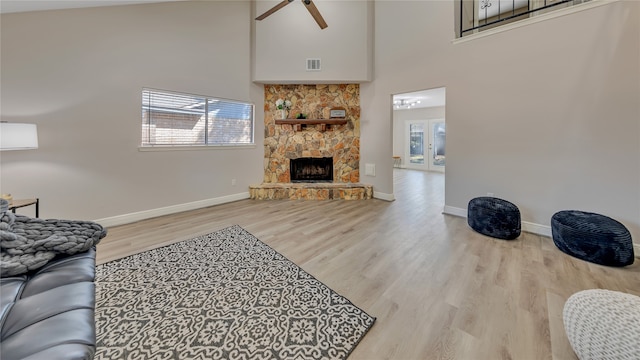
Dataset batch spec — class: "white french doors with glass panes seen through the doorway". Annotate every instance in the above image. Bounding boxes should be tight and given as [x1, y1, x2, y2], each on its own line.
[404, 119, 446, 172]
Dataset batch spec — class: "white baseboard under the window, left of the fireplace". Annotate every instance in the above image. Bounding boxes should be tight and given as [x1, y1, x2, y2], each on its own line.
[93, 192, 249, 228]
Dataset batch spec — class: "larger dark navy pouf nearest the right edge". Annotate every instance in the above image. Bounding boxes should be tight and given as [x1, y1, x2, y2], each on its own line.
[551, 210, 633, 266]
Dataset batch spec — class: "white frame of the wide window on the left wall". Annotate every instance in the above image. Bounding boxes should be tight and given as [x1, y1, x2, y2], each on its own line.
[138, 87, 256, 151]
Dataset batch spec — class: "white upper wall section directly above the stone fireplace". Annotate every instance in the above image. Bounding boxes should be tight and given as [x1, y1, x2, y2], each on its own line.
[253, 0, 373, 84]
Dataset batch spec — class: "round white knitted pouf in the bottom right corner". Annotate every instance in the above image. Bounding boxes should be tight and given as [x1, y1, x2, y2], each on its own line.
[562, 289, 640, 360]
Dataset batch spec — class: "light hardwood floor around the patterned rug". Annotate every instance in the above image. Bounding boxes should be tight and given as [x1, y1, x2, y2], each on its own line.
[98, 169, 640, 360]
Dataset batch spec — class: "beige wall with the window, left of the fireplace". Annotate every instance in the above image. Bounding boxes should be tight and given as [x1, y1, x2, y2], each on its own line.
[0, 1, 264, 224]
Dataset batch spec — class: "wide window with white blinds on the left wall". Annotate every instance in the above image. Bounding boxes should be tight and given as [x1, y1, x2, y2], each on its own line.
[141, 89, 254, 146]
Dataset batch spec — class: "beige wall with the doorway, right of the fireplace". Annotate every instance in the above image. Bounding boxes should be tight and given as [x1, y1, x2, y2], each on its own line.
[361, 1, 640, 242]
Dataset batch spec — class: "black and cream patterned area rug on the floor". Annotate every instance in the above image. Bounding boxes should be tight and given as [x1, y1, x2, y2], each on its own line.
[95, 225, 375, 360]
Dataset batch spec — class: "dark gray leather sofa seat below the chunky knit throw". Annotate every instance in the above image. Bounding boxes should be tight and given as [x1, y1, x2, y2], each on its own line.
[0, 248, 95, 360]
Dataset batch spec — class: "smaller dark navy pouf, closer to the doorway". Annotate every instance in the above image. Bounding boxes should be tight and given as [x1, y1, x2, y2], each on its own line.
[467, 196, 520, 240]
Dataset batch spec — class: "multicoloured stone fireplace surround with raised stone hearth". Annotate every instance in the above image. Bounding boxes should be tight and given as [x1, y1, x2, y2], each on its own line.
[249, 84, 373, 200]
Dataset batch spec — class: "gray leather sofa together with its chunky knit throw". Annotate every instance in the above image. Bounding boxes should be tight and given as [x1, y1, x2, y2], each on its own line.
[0, 203, 106, 360]
